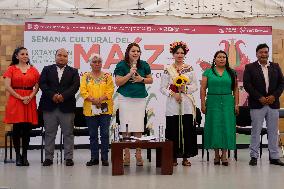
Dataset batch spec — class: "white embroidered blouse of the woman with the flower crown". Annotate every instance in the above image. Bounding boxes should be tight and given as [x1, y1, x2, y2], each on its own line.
[160, 64, 198, 116]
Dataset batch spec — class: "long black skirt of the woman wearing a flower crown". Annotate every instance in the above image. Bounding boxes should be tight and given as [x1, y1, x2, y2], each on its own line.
[165, 114, 198, 158]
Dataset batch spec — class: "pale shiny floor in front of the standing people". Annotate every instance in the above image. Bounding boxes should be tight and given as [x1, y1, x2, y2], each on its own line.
[0, 149, 284, 189]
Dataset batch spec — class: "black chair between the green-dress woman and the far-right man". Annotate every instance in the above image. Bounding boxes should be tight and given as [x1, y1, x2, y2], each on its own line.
[234, 106, 267, 161]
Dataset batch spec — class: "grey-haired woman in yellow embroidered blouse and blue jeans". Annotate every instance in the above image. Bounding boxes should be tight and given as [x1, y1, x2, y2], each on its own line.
[80, 54, 114, 166]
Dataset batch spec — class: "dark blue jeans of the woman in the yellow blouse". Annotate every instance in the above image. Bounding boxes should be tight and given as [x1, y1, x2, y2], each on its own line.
[86, 114, 111, 161]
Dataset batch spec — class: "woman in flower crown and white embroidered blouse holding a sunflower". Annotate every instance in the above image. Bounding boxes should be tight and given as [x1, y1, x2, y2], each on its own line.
[160, 41, 198, 166]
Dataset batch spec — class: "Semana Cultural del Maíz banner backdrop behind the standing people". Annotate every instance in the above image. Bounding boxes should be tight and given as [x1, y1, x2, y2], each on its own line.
[24, 22, 272, 143]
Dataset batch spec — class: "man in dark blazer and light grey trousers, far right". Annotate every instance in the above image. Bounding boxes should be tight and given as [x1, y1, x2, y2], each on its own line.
[243, 44, 284, 166]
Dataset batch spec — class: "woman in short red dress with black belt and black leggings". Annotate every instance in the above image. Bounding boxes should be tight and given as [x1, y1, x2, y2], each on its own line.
[3, 47, 39, 166]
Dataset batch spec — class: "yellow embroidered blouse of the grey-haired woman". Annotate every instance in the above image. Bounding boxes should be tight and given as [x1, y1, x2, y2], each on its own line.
[80, 72, 114, 116]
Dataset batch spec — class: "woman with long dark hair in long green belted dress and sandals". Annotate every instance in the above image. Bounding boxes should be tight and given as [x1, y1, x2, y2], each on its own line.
[200, 51, 239, 166]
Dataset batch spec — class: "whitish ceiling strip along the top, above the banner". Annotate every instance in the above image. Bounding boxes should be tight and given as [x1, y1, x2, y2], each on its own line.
[0, 0, 284, 18]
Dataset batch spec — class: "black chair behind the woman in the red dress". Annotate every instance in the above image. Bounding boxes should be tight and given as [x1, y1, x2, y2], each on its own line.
[4, 110, 45, 163]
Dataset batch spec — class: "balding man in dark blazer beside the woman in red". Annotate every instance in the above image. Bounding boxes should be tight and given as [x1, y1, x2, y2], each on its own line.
[39, 49, 80, 166]
